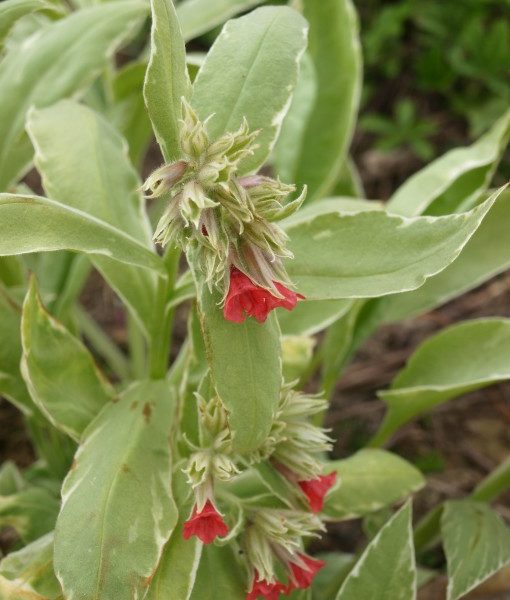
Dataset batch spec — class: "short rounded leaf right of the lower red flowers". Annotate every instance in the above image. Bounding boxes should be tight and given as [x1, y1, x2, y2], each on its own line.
[324, 448, 425, 520]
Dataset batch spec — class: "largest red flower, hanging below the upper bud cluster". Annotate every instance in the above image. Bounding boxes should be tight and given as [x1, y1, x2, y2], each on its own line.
[223, 267, 304, 323]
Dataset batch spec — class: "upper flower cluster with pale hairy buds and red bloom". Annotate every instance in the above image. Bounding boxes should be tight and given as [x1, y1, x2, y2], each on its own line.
[144, 100, 305, 322]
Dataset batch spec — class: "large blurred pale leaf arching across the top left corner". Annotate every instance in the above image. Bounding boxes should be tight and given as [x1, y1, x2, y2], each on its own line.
[0, 0, 147, 190]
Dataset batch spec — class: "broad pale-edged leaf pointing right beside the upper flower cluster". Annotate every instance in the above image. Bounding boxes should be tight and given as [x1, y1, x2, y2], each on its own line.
[286, 193, 497, 300]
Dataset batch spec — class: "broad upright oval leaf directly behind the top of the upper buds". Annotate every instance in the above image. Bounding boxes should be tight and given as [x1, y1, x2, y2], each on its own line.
[192, 6, 308, 172]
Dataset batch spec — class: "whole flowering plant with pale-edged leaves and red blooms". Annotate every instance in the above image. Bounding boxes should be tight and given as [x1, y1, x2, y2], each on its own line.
[0, 0, 510, 600]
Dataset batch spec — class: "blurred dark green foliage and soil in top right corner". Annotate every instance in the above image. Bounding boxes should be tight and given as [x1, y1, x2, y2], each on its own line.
[355, 0, 510, 160]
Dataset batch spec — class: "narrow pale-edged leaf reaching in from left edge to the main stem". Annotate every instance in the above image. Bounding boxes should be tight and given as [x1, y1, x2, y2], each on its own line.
[0, 194, 164, 273]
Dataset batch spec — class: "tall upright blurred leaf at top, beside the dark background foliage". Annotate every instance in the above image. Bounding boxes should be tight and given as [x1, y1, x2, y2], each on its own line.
[293, 0, 362, 199]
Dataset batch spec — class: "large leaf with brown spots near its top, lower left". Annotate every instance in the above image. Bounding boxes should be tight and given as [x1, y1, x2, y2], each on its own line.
[55, 381, 177, 600]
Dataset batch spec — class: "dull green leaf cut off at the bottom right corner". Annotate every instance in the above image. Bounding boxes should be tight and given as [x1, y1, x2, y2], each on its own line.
[441, 500, 510, 600]
